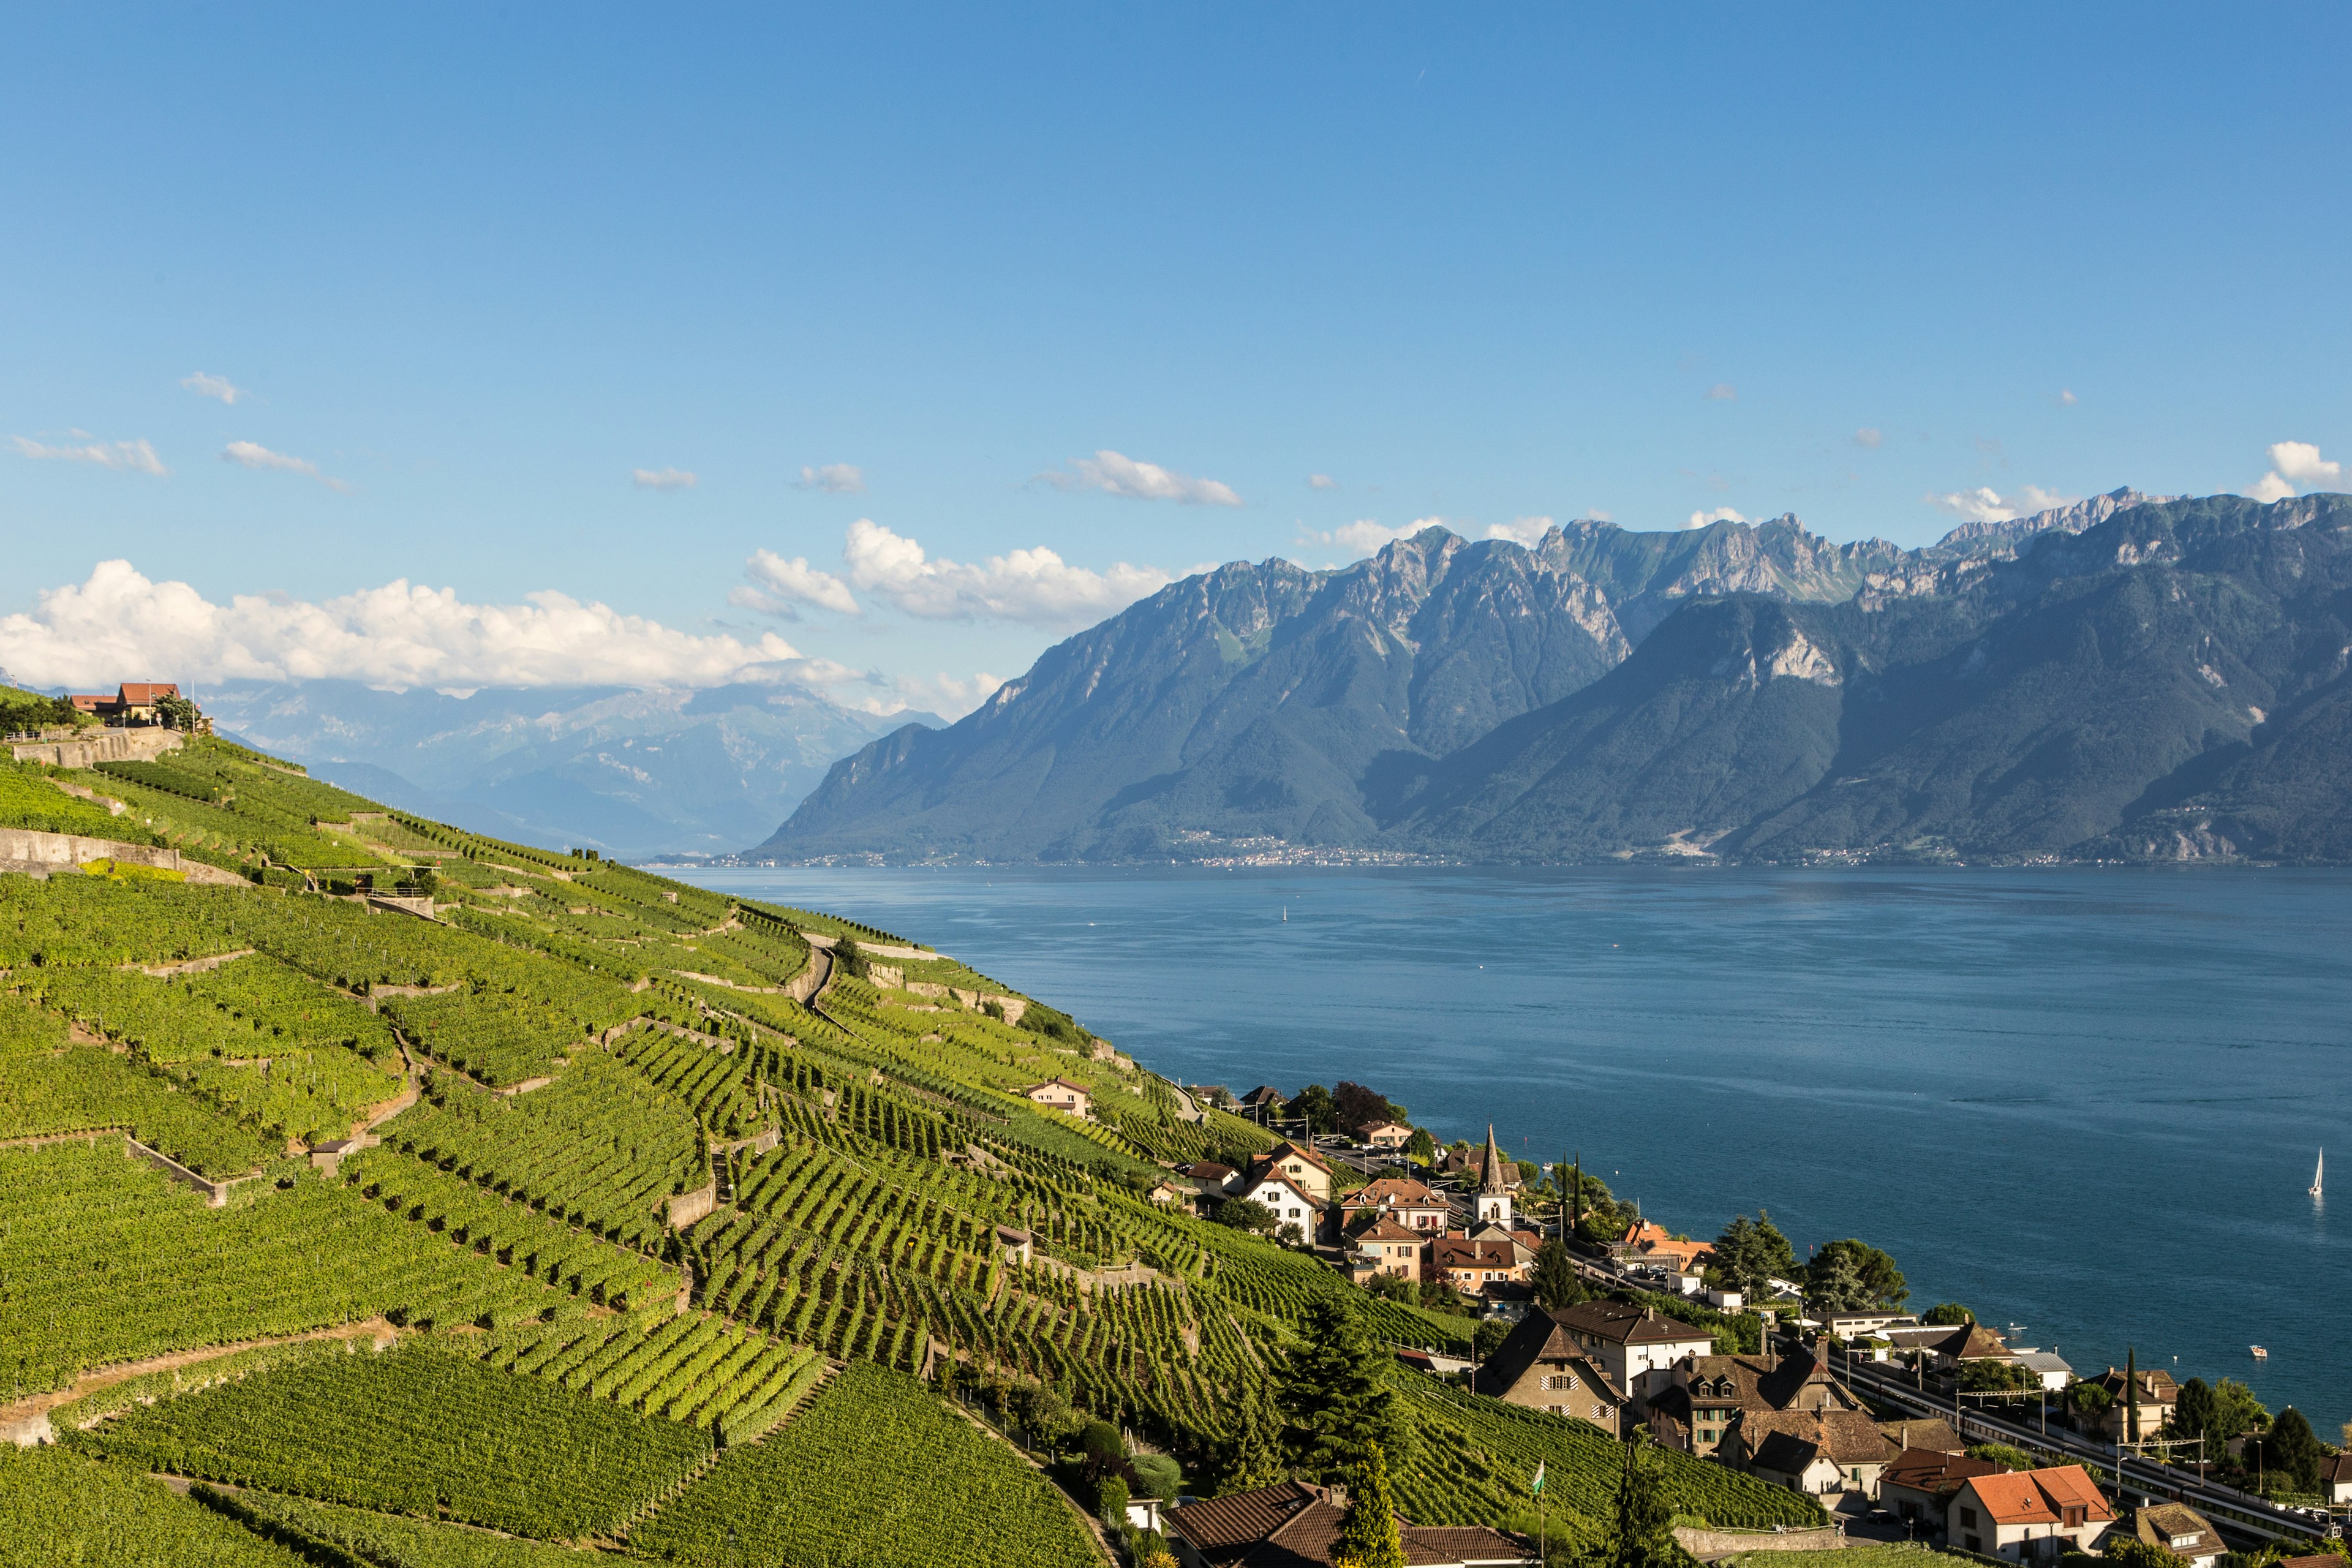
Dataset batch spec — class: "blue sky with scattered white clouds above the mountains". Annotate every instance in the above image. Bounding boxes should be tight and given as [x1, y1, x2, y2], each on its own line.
[0, 5, 2352, 712]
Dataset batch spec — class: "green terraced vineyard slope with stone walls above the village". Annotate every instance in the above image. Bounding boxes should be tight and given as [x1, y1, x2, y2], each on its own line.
[0, 719, 1814, 1568]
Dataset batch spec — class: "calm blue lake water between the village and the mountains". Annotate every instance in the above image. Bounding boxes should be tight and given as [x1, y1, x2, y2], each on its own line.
[677, 867, 2352, 1439]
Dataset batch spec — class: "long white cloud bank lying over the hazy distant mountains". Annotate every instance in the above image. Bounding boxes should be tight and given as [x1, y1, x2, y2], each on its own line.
[0, 559, 828, 689]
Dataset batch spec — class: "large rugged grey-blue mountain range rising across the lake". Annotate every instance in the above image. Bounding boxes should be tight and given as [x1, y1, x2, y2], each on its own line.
[750, 489, 2352, 863]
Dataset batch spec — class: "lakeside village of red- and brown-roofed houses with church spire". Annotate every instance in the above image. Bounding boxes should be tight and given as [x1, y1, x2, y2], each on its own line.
[1028, 1079, 2352, 1568]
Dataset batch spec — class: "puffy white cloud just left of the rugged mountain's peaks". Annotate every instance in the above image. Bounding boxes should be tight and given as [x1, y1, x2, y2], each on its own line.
[846, 517, 1171, 630]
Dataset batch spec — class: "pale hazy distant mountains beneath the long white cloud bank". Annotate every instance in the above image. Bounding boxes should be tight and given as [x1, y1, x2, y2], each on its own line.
[200, 682, 938, 856]
